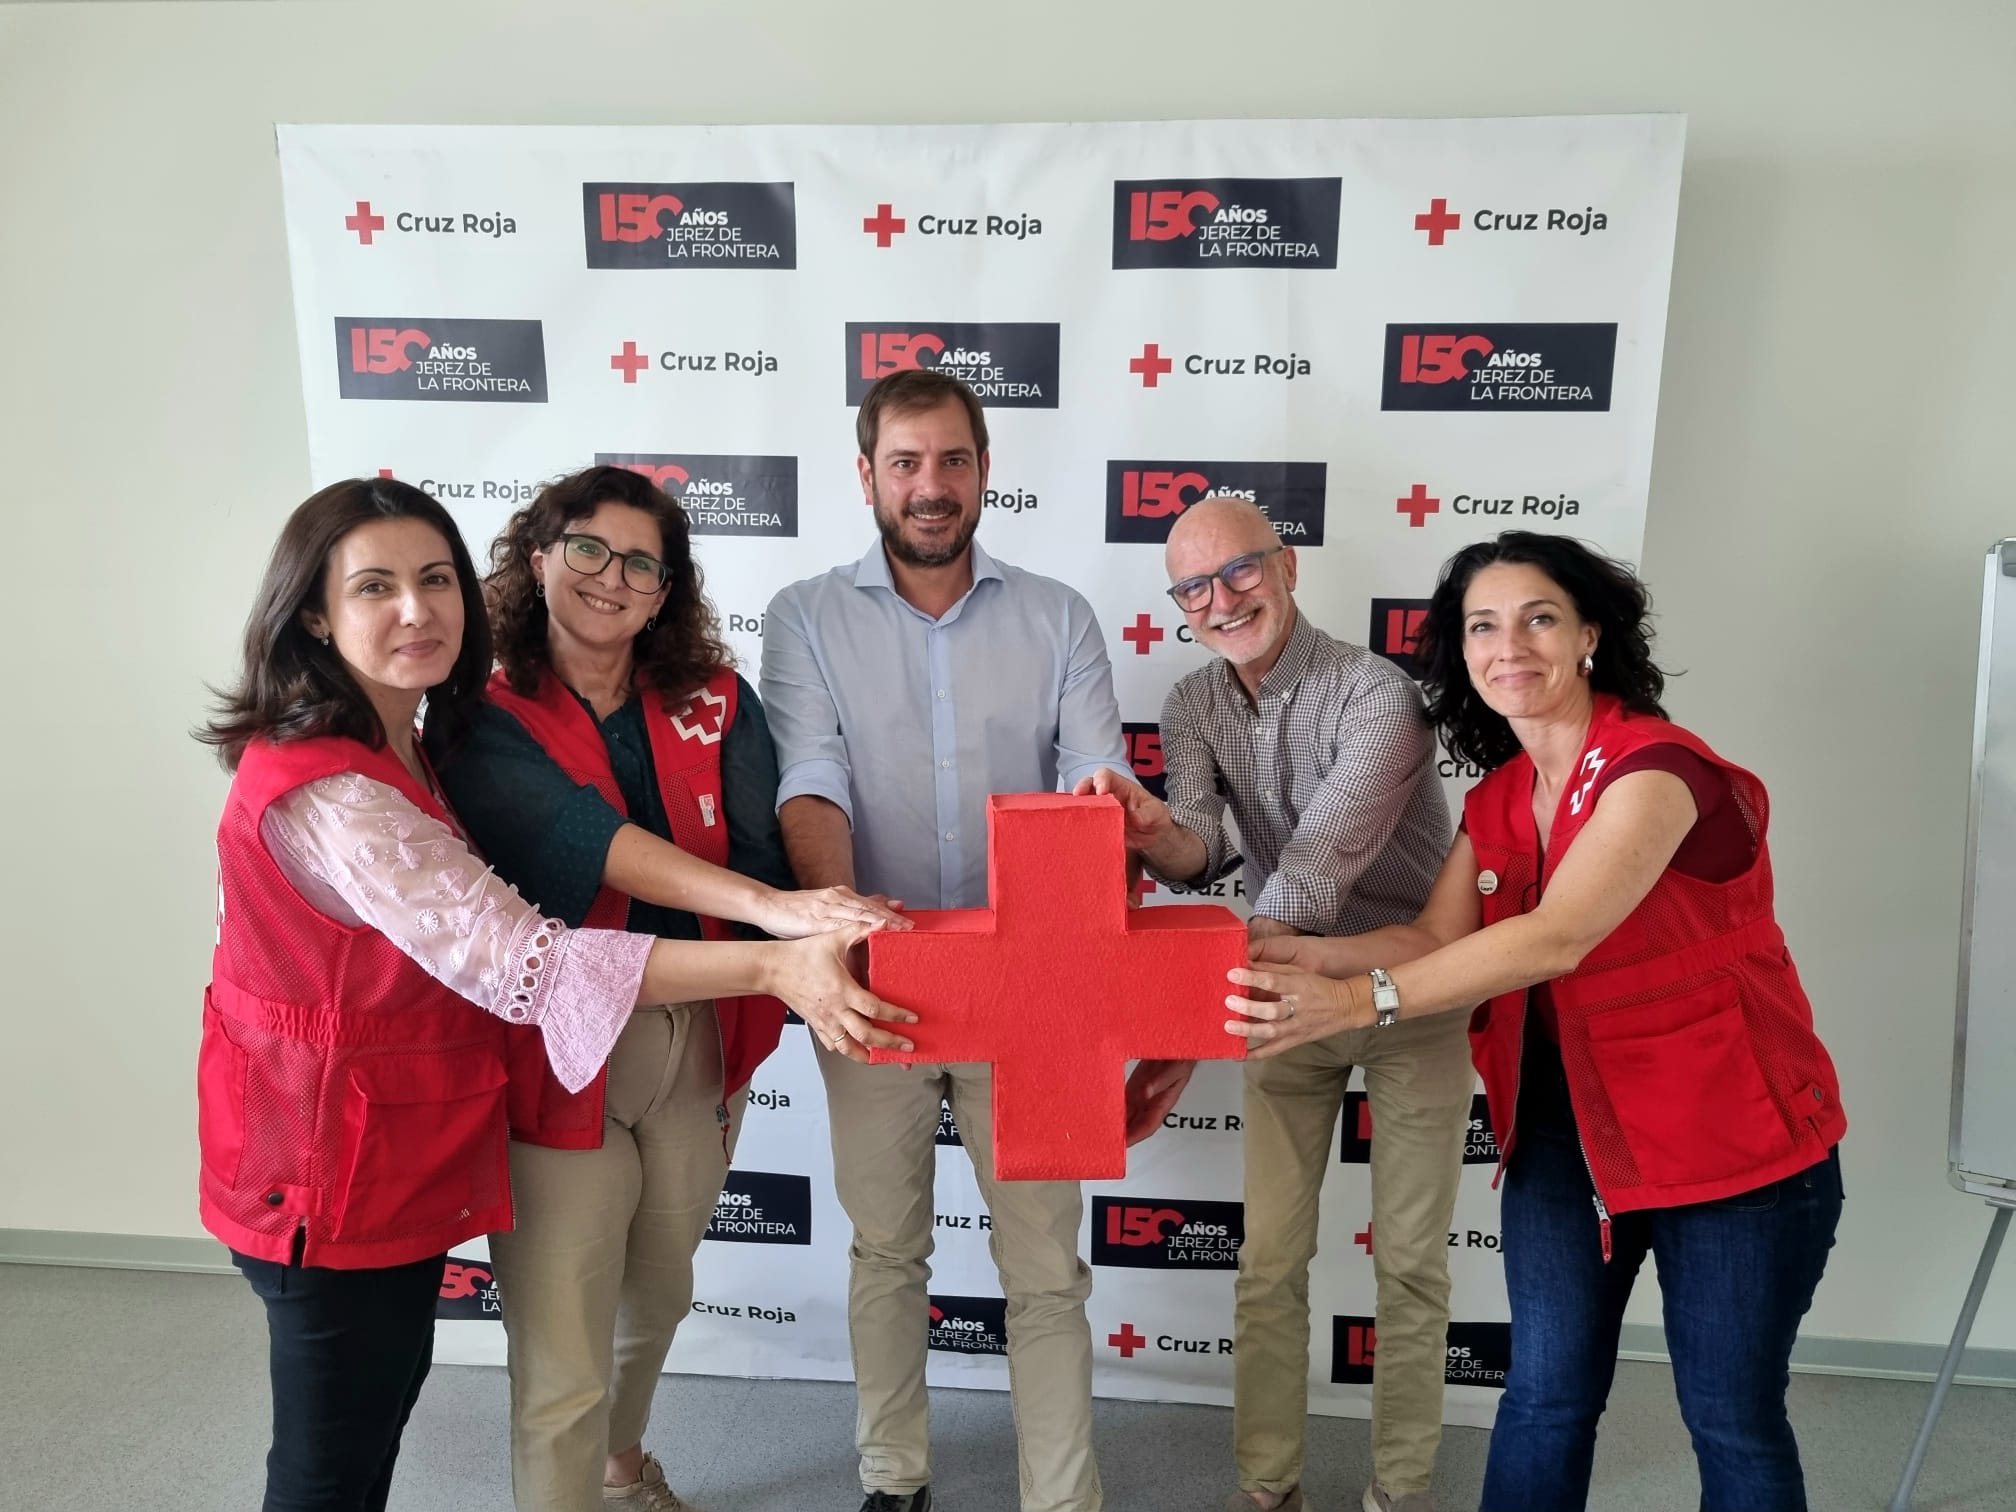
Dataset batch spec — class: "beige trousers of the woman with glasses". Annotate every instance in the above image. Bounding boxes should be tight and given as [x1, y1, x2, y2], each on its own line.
[490, 1002, 746, 1512]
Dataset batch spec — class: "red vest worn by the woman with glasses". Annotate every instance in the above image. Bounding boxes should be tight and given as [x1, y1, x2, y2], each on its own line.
[490, 667, 784, 1149]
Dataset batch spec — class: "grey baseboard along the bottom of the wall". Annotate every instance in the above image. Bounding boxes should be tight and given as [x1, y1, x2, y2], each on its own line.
[0, 1228, 2016, 1387]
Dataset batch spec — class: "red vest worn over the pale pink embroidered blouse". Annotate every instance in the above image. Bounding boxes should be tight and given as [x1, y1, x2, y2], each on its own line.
[196, 738, 512, 1270]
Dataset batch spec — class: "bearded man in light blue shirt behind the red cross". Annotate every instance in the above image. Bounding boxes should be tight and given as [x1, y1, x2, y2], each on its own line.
[762, 369, 1129, 1512]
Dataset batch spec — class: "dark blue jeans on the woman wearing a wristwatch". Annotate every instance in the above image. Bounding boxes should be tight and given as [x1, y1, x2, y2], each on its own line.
[1480, 1030, 1843, 1512]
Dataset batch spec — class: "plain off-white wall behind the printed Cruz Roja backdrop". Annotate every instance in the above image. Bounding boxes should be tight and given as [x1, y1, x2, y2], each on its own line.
[0, 0, 2016, 1349]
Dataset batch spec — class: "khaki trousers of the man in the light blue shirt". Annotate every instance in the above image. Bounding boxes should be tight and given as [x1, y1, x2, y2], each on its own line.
[818, 1046, 1103, 1512]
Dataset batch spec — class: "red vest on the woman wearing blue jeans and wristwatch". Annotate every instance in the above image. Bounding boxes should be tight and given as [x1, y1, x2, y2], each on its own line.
[1464, 696, 1849, 1212]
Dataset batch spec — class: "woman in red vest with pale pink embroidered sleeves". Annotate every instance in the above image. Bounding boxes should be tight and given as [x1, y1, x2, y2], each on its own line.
[198, 478, 907, 1512]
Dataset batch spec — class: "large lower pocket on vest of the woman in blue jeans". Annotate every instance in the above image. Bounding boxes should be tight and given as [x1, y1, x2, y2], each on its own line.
[1587, 976, 1792, 1185]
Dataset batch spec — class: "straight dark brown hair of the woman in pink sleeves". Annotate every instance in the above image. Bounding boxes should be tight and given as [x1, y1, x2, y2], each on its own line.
[192, 478, 490, 772]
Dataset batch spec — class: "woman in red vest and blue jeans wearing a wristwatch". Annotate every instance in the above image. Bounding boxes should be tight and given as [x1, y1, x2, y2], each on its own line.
[1228, 530, 1847, 1512]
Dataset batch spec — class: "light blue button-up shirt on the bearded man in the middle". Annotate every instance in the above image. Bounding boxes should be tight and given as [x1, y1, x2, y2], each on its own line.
[760, 540, 1129, 909]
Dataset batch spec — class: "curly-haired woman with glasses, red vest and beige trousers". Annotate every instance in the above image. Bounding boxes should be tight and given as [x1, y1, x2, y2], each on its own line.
[427, 468, 907, 1512]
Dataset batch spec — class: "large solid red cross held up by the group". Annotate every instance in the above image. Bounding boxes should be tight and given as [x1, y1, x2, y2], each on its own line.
[869, 794, 1246, 1181]
